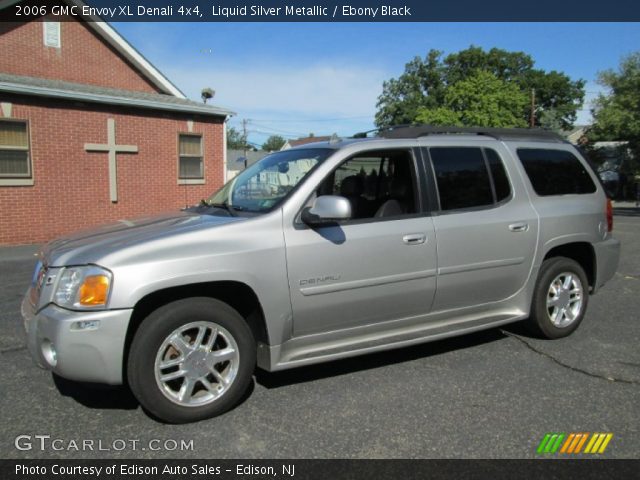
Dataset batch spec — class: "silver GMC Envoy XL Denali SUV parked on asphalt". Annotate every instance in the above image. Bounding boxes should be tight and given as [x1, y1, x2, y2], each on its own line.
[22, 127, 620, 423]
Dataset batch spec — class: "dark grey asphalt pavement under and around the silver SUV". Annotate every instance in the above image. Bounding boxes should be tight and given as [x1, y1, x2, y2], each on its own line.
[0, 213, 640, 458]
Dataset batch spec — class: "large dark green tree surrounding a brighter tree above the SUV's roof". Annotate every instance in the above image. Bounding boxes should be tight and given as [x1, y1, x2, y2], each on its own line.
[376, 46, 584, 128]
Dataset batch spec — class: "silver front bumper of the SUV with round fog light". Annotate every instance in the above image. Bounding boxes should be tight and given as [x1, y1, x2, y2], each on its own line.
[22, 293, 132, 385]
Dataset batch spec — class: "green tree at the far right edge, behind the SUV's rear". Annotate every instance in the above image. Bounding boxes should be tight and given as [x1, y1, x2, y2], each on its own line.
[588, 51, 640, 174]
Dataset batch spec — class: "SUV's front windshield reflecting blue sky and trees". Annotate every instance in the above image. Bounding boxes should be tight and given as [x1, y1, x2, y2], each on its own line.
[205, 148, 333, 213]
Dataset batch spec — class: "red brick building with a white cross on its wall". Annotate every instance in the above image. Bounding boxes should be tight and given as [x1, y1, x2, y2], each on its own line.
[0, 0, 231, 244]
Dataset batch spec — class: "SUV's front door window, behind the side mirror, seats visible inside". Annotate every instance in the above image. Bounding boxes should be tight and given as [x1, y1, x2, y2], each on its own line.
[316, 150, 417, 220]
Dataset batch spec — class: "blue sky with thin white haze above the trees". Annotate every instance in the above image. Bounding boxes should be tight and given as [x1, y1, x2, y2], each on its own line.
[114, 23, 640, 144]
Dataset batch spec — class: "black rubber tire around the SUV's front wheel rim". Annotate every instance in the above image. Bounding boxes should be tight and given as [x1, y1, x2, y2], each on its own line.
[127, 297, 256, 423]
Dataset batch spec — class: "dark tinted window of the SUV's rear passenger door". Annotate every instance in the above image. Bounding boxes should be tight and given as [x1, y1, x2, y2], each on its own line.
[429, 147, 511, 211]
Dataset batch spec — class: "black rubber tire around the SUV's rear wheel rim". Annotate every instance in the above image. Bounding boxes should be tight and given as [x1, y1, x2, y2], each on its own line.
[526, 257, 589, 339]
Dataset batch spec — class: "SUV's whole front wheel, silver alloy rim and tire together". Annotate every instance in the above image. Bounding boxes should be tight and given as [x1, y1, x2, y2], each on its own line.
[127, 298, 256, 423]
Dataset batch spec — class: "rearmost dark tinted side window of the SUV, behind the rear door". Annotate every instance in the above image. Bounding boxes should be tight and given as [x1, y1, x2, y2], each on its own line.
[518, 148, 596, 197]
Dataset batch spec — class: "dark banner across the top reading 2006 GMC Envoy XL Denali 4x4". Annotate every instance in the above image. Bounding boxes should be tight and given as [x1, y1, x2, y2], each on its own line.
[0, 0, 640, 22]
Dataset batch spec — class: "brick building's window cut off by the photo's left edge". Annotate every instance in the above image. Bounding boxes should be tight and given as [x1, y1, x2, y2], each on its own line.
[0, 120, 31, 180]
